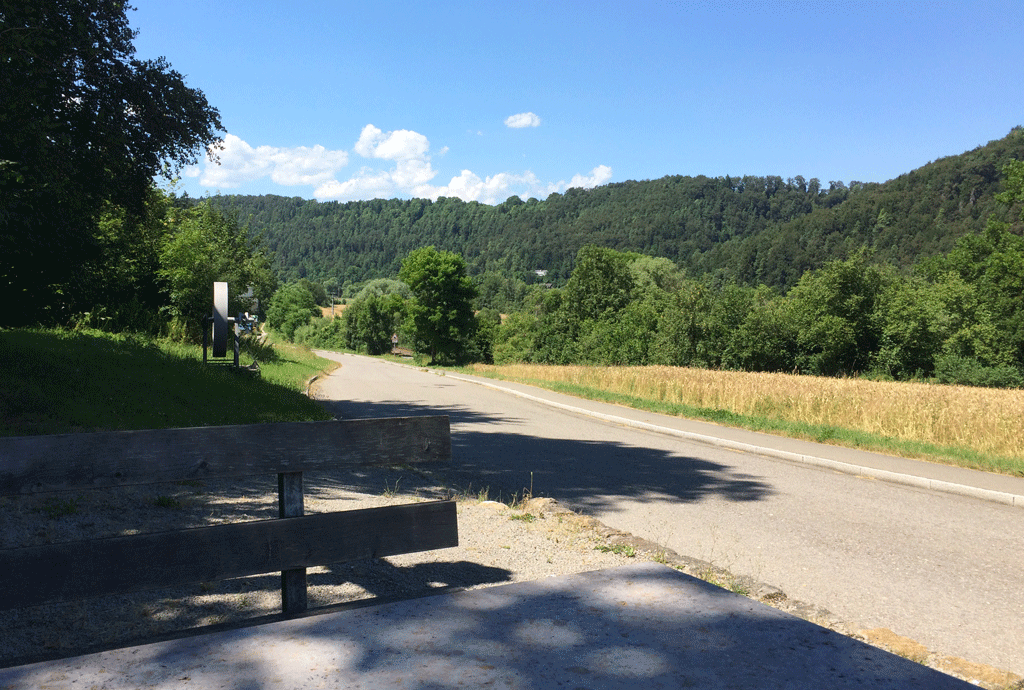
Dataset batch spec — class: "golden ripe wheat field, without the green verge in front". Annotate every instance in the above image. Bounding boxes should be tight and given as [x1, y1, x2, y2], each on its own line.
[468, 364, 1024, 459]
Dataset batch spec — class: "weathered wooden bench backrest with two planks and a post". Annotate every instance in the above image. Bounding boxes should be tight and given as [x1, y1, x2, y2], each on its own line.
[0, 417, 459, 615]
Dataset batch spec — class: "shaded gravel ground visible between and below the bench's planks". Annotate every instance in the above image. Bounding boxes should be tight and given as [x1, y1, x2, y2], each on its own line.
[0, 468, 513, 667]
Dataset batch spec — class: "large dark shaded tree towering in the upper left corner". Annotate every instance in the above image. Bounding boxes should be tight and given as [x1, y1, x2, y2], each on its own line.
[0, 0, 222, 325]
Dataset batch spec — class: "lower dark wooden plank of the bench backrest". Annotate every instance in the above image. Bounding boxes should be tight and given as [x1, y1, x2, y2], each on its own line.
[0, 501, 459, 609]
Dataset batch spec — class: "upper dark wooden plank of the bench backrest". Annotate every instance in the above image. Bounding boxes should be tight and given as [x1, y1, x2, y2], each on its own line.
[0, 417, 452, 495]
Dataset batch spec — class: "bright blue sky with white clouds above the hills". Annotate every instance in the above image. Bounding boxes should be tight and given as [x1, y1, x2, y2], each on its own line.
[129, 0, 1024, 204]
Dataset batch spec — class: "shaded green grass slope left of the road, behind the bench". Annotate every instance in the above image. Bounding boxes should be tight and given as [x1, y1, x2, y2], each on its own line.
[0, 330, 332, 436]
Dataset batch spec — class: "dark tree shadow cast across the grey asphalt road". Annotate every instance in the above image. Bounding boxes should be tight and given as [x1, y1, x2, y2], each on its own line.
[323, 401, 772, 512]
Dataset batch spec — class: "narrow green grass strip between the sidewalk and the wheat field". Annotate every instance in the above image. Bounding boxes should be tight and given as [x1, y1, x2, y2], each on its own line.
[459, 369, 1024, 477]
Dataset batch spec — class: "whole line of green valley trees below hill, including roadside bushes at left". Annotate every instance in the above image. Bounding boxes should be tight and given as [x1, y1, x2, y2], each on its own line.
[272, 162, 1024, 387]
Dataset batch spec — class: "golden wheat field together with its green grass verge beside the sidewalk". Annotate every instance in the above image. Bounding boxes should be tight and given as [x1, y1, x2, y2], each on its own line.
[468, 364, 1024, 476]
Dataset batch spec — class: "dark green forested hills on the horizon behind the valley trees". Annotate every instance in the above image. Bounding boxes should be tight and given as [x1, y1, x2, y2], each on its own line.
[201, 127, 1024, 288]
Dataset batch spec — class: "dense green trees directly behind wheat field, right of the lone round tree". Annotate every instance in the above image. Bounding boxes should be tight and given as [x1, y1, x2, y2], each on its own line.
[492, 214, 1024, 387]
